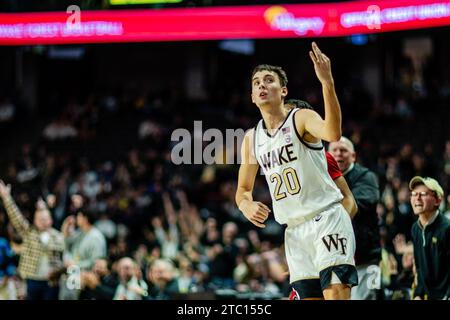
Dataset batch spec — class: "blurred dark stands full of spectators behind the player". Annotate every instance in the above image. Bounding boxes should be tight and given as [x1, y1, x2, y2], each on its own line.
[0, 3, 450, 300]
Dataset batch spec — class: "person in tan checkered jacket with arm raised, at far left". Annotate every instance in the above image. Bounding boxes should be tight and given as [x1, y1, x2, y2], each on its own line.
[0, 180, 64, 300]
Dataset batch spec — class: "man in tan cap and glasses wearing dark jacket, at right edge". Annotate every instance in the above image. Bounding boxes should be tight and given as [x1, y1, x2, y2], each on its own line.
[409, 176, 450, 300]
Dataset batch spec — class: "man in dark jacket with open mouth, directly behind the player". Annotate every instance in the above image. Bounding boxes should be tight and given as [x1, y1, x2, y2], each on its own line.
[328, 137, 380, 300]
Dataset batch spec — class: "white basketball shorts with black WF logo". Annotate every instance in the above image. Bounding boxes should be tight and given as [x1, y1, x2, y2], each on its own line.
[285, 203, 358, 296]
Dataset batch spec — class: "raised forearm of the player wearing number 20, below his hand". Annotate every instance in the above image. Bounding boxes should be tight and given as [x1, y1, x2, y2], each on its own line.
[322, 79, 342, 142]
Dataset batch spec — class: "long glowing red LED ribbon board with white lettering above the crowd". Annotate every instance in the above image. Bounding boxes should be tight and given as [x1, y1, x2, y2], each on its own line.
[0, 0, 450, 45]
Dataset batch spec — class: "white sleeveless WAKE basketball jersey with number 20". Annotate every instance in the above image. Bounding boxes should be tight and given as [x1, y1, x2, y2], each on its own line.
[253, 109, 343, 224]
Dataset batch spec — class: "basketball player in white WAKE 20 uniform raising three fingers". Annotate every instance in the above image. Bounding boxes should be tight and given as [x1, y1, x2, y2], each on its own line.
[236, 43, 358, 300]
